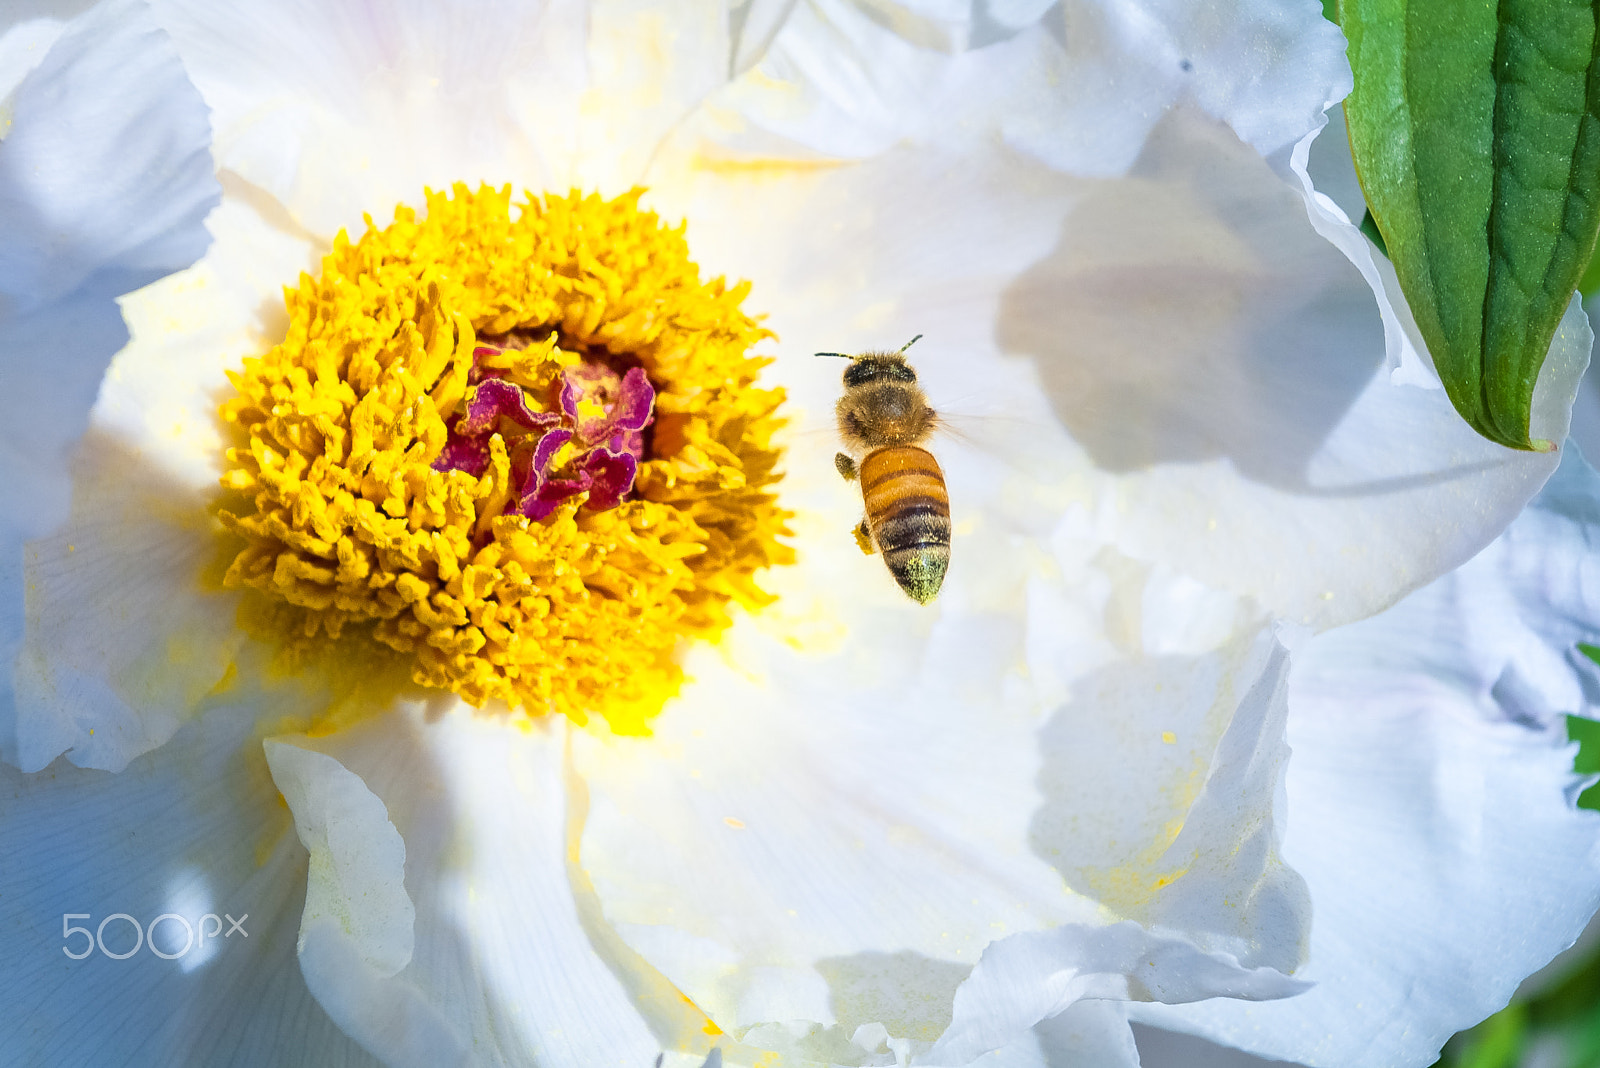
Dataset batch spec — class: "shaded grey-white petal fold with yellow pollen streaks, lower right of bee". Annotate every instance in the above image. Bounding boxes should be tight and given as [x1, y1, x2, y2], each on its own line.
[1030, 617, 1310, 972]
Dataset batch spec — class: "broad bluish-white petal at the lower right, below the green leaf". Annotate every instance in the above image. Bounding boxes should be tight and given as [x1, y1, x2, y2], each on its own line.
[1134, 449, 1600, 1068]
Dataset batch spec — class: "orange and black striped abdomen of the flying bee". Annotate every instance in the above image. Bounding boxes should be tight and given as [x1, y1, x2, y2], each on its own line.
[861, 446, 950, 604]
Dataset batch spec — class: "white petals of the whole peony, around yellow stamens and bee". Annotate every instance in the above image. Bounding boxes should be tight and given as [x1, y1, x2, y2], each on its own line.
[0, 0, 1600, 1068]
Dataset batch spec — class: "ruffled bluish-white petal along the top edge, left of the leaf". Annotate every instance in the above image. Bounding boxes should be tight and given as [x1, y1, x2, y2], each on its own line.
[691, 0, 1350, 176]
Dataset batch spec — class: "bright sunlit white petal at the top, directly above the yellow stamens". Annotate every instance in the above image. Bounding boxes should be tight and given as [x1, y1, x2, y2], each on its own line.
[157, 0, 764, 237]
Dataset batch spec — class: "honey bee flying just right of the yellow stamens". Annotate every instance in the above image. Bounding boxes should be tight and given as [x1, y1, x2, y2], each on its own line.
[816, 334, 950, 604]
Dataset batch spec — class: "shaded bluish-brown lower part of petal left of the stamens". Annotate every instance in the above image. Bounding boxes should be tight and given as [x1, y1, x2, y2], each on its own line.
[0, 433, 245, 771]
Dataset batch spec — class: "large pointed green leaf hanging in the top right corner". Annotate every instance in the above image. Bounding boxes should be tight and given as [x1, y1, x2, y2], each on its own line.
[1339, 0, 1600, 451]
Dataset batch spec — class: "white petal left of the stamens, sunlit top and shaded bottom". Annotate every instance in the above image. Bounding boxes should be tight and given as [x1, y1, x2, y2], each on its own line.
[0, 191, 315, 771]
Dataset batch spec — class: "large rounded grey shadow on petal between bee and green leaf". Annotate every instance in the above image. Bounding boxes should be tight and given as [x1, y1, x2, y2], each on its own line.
[997, 110, 1382, 488]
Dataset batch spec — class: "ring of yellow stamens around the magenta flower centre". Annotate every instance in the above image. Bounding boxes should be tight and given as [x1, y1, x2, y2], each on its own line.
[219, 185, 792, 732]
